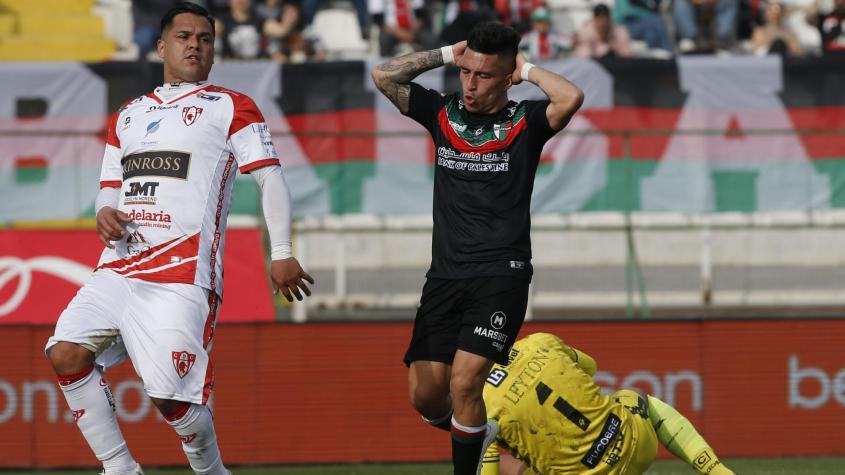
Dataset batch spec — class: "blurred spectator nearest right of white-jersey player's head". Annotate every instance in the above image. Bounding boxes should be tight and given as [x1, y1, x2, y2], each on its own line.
[217, 0, 266, 59]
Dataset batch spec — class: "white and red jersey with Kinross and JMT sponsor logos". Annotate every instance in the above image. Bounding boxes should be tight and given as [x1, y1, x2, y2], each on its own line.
[97, 83, 279, 296]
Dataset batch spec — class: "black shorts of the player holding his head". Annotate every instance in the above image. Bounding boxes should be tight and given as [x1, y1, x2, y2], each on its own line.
[405, 276, 528, 366]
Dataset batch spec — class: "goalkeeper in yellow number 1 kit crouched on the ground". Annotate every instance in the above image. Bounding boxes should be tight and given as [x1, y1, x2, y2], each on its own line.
[480, 333, 733, 475]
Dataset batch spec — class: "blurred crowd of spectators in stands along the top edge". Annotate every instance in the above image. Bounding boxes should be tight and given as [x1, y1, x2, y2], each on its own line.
[132, 0, 845, 63]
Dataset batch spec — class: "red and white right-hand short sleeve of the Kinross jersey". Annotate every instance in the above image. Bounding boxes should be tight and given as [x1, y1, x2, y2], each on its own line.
[229, 95, 279, 173]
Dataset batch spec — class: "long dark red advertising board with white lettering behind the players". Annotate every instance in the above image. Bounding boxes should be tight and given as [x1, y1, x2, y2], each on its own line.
[0, 320, 845, 467]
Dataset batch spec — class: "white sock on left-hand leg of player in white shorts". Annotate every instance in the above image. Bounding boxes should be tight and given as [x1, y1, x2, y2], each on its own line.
[59, 368, 137, 473]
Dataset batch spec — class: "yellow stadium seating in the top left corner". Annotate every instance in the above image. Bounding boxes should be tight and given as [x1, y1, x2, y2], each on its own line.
[0, 0, 116, 61]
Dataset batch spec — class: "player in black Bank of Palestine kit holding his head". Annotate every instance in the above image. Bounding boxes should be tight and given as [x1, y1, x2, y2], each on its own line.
[372, 22, 583, 475]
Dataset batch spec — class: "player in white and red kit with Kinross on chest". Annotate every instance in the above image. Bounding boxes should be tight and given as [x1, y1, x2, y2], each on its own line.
[46, 3, 314, 475]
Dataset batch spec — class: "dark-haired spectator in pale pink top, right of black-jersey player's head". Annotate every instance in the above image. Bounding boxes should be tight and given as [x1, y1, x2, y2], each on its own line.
[575, 4, 631, 58]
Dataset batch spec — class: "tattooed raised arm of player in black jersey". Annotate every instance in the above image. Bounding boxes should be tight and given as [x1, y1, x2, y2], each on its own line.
[373, 49, 443, 114]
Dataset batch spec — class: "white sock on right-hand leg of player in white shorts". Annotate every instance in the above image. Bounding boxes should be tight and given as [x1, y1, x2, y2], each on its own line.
[168, 404, 229, 475]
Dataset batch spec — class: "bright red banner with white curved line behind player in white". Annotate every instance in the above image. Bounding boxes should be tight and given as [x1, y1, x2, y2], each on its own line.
[0, 229, 275, 325]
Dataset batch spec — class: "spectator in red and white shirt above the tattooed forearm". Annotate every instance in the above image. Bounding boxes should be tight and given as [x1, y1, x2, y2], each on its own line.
[369, 0, 437, 57]
